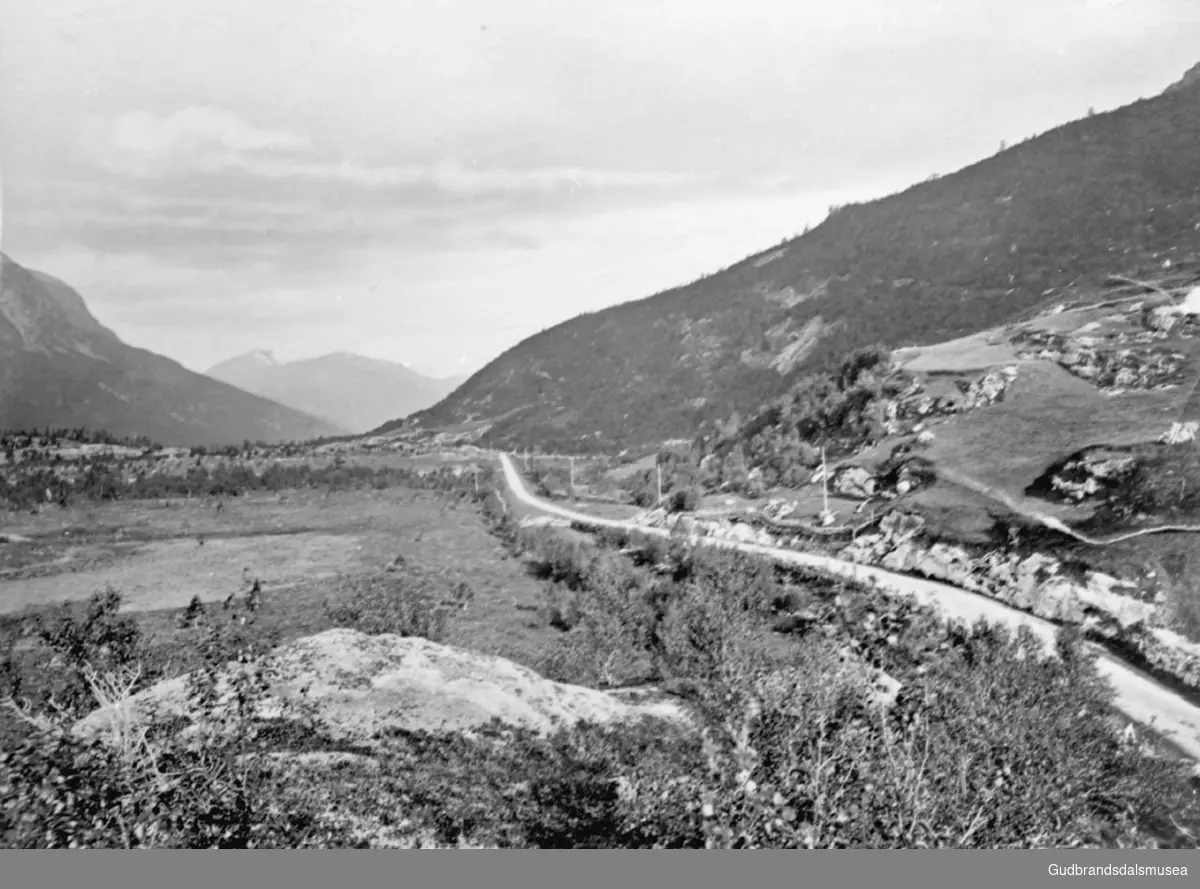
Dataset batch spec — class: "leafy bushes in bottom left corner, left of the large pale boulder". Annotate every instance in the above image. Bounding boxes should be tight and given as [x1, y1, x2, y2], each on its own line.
[0, 591, 357, 848]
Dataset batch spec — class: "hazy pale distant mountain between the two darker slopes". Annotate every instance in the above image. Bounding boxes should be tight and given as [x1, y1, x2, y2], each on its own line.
[208, 352, 462, 432]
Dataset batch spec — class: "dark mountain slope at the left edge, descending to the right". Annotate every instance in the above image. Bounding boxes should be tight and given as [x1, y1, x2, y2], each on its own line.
[0, 254, 342, 445]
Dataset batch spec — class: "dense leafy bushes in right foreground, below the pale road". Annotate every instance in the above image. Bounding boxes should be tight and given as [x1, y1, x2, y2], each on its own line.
[501, 523, 1198, 848]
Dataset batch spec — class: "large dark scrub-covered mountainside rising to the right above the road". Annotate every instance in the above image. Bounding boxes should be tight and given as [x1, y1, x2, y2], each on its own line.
[383, 60, 1200, 451]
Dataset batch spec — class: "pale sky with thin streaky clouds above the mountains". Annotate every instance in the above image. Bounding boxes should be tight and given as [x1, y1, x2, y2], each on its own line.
[0, 0, 1200, 376]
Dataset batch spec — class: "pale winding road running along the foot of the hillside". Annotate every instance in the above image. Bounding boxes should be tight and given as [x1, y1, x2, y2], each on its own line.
[496, 452, 1200, 771]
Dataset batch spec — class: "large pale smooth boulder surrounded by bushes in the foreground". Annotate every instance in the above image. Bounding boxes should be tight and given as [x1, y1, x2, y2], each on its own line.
[76, 629, 688, 746]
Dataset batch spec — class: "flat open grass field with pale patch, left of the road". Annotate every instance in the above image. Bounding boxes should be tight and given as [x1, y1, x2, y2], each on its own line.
[0, 488, 552, 663]
